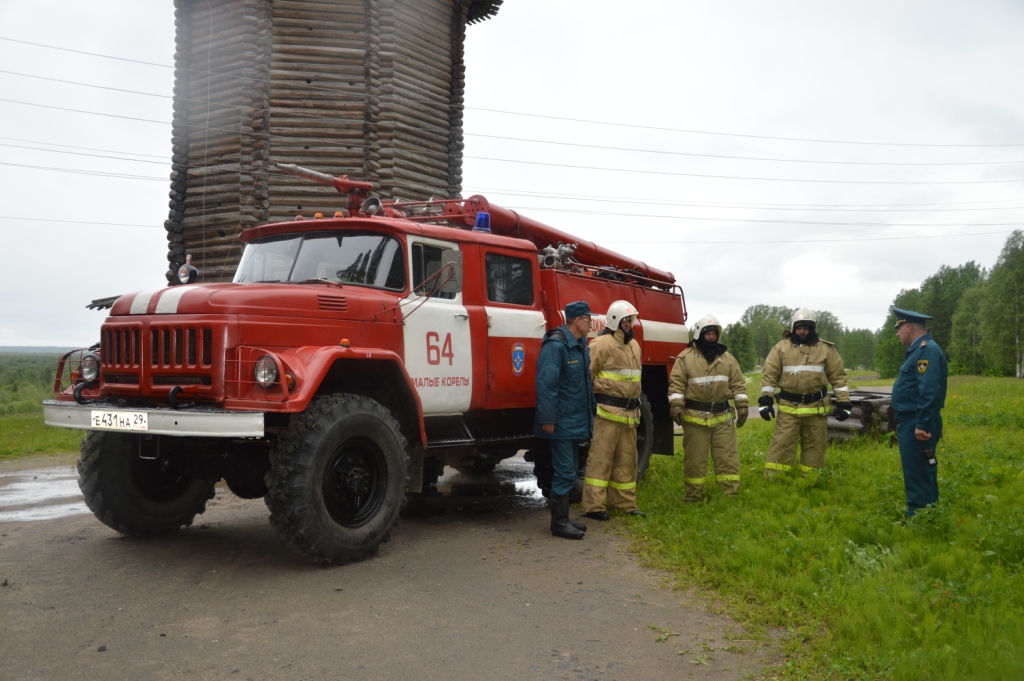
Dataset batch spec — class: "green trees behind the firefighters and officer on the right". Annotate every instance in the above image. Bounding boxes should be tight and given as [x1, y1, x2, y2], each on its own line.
[722, 229, 1024, 378]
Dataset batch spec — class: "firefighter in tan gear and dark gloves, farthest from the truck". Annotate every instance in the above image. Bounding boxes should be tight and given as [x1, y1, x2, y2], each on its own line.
[758, 308, 851, 476]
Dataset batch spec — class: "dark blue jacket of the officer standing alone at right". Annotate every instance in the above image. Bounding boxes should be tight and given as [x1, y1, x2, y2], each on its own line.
[893, 334, 948, 433]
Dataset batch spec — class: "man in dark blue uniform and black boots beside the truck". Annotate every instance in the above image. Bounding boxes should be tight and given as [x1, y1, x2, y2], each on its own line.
[534, 300, 597, 539]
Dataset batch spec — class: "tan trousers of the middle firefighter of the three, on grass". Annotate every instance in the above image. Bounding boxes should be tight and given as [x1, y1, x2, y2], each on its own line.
[683, 419, 739, 502]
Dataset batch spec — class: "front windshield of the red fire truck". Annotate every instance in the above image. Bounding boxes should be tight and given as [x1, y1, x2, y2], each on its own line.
[234, 232, 406, 291]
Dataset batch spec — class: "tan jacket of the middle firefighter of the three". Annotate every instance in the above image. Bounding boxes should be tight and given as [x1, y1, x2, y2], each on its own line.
[669, 345, 748, 425]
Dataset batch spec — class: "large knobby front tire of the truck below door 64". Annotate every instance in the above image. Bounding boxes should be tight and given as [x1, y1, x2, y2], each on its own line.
[264, 394, 410, 564]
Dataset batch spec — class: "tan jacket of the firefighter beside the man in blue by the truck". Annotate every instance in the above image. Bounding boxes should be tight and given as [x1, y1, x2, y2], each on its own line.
[590, 329, 643, 426]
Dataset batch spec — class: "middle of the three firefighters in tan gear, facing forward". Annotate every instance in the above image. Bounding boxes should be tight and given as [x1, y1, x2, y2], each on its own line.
[669, 314, 749, 502]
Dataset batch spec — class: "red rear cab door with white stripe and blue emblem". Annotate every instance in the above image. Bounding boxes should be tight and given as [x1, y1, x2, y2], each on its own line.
[483, 247, 546, 410]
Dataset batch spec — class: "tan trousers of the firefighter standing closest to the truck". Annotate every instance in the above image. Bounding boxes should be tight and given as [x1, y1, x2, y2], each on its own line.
[580, 417, 637, 513]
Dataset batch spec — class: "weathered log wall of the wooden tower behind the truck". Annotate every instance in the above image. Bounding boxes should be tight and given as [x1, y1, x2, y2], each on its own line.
[165, 0, 501, 282]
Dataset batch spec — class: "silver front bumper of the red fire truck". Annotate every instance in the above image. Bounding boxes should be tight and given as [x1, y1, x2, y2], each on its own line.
[43, 399, 263, 437]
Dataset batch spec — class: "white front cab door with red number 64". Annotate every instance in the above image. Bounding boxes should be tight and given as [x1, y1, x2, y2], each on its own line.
[401, 237, 473, 416]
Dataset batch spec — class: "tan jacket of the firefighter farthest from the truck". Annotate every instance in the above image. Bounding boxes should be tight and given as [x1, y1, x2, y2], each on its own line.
[761, 335, 850, 416]
